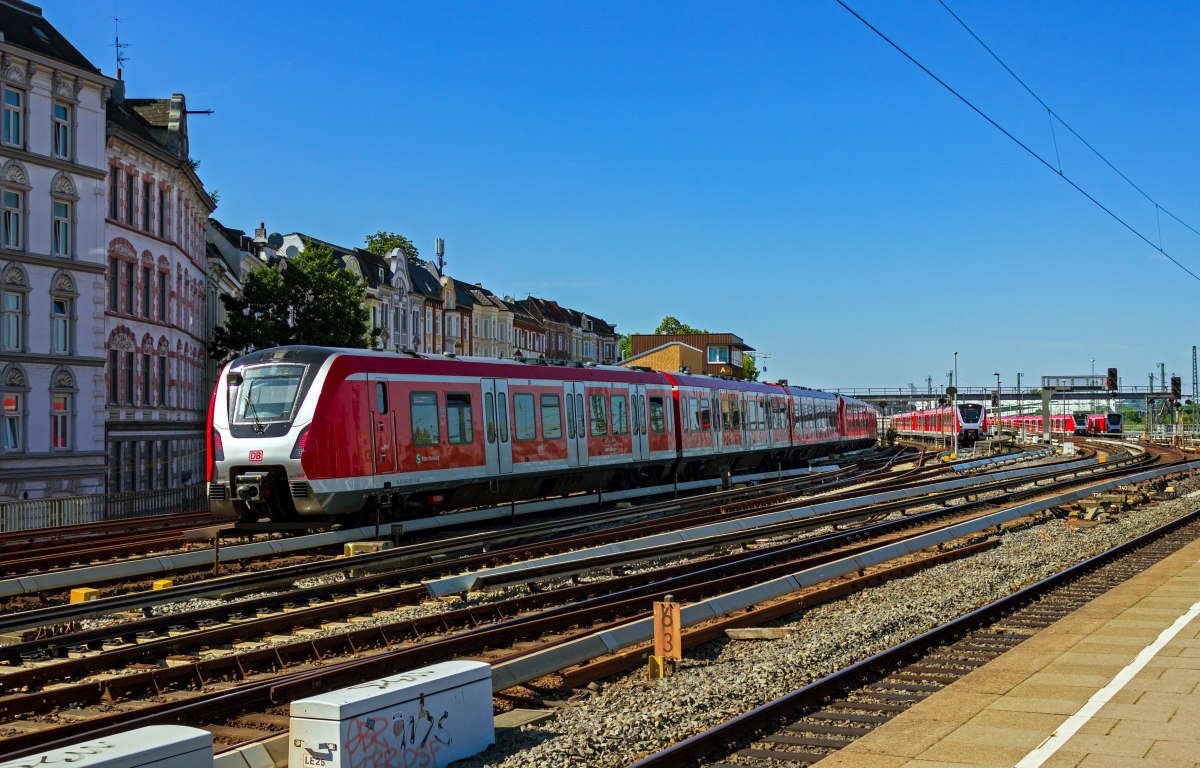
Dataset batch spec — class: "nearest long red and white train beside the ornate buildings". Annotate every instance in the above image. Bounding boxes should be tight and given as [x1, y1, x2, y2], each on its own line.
[208, 347, 876, 521]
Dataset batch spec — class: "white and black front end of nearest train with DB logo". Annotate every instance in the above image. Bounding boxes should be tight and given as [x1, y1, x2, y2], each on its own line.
[208, 347, 337, 521]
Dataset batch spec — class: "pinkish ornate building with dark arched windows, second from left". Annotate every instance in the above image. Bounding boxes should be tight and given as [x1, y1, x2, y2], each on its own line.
[104, 83, 216, 492]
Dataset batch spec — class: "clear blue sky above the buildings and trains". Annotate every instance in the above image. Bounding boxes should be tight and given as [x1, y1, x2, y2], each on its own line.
[43, 0, 1200, 388]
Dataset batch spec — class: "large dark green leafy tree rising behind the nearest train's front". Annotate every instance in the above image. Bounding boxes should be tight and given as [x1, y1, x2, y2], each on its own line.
[210, 241, 380, 362]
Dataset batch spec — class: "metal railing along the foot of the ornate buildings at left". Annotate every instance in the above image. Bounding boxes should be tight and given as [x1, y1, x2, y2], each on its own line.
[0, 485, 208, 533]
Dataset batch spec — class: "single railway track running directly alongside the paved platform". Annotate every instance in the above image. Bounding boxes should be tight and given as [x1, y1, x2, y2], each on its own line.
[634, 511, 1200, 768]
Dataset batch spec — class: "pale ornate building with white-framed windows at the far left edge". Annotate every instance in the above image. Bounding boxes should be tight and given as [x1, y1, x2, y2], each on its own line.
[0, 2, 114, 500]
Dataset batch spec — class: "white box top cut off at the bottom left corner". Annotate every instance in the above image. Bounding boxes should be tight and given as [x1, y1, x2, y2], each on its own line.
[0, 725, 212, 768]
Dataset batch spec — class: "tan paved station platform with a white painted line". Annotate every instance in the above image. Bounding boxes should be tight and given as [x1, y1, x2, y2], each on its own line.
[817, 532, 1200, 768]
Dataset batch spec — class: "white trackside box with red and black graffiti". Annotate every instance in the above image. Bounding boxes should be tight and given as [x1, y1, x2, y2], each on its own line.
[288, 661, 496, 768]
